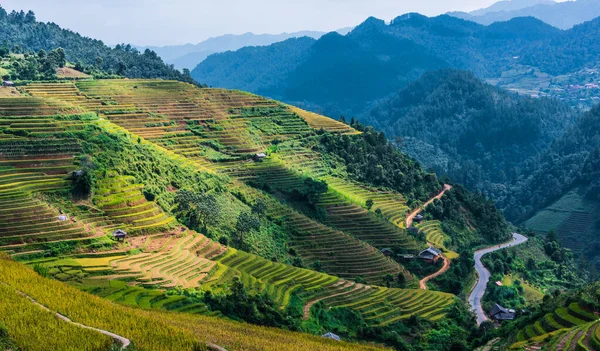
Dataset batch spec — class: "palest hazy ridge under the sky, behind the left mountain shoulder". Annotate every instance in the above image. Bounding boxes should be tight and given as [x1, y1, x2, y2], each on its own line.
[137, 28, 352, 69]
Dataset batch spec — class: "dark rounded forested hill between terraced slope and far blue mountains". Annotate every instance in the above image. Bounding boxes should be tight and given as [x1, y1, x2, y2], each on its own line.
[363, 70, 577, 204]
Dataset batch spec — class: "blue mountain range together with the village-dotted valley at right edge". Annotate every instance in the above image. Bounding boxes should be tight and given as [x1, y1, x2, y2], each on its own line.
[192, 14, 600, 116]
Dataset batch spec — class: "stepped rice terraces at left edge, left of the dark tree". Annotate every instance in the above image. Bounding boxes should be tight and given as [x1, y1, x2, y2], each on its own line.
[0, 98, 99, 253]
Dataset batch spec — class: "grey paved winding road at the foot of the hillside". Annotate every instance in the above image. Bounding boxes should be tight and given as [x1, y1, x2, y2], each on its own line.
[469, 233, 527, 325]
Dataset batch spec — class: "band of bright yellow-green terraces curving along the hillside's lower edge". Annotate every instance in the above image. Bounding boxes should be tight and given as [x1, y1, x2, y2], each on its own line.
[39, 233, 454, 324]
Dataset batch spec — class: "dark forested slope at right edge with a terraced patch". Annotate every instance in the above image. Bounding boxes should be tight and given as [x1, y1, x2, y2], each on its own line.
[502, 106, 600, 267]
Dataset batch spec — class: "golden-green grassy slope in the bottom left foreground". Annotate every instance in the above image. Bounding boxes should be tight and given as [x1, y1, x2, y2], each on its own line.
[0, 253, 386, 350]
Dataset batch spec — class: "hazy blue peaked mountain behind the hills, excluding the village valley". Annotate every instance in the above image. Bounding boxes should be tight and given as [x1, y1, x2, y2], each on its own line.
[192, 14, 563, 116]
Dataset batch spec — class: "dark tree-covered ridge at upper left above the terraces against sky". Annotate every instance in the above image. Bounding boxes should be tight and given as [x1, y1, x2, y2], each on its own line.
[0, 7, 195, 83]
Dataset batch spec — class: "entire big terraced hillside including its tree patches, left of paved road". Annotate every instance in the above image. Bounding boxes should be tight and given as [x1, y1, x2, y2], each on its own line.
[0, 79, 509, 349]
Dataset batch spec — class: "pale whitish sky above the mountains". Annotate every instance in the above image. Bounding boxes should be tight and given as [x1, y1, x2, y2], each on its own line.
[0, 0, 520, 45]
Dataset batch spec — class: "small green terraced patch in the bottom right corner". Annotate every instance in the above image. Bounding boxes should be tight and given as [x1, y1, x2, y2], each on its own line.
[517, 303, 598, 341]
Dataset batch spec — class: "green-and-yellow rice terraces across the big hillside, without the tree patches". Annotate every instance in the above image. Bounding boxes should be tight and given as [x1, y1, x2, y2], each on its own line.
[0, 80, 455, 338]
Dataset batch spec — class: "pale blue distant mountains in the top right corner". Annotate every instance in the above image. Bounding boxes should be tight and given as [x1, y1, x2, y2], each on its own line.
[449, 0, 600, 29]
